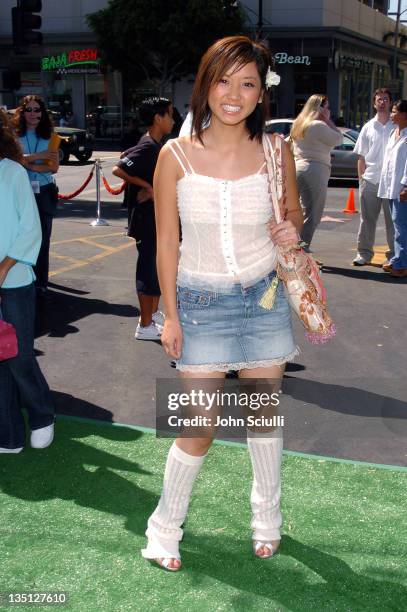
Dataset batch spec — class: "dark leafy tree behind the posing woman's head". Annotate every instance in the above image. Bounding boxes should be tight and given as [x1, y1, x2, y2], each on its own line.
[87, 0, 244, 92]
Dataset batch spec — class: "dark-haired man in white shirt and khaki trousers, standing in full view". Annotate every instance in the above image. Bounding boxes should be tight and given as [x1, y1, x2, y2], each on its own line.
[353, 89, 394, 266]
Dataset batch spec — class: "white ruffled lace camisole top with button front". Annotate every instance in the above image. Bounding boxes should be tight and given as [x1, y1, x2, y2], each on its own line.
[168, 140, 277, 291]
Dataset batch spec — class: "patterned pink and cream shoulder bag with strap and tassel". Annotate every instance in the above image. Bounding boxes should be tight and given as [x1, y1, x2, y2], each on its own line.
[260, 135, 336, 344]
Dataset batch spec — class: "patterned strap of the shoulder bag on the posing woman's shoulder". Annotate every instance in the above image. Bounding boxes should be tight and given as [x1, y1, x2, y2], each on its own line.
[262, 134, 287, 223]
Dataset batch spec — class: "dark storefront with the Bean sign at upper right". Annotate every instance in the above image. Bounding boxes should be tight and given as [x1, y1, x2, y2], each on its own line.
[268, 29, 407, 129]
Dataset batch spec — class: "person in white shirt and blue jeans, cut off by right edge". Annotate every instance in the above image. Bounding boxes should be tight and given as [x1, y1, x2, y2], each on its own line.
[378, 100, 407, 278]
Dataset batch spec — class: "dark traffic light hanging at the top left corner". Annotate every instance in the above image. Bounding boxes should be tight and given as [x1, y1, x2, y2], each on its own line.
[11, 0, 42, 49]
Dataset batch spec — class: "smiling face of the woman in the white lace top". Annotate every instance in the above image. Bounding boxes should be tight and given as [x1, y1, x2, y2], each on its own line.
[208, 62, 263, 125]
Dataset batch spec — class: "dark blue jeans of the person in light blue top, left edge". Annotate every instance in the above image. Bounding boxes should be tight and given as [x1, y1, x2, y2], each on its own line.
[0, 284, 55, 448]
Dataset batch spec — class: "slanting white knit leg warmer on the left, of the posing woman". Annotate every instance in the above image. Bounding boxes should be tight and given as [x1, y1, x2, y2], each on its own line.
[141, 442, 206, 559]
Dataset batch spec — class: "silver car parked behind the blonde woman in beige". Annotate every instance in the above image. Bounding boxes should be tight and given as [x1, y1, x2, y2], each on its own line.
[266, 119, 359, 178]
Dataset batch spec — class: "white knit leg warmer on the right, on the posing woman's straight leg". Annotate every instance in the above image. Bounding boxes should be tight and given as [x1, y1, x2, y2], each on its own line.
[247, 431, 283, 542]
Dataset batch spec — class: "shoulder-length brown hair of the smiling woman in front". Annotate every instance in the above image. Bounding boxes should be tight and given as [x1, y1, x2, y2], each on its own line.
[191, 36, 274, 144]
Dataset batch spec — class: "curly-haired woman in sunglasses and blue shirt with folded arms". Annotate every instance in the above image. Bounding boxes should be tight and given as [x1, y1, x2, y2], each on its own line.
[14, 95, 59, 297]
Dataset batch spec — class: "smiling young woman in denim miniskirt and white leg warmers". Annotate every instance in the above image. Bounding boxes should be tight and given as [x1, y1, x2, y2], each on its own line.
[142, 36, 302, 571]
